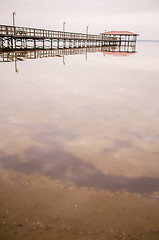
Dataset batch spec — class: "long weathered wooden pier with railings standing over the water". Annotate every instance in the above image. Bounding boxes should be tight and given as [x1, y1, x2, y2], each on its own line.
[0, 25, 137, 50]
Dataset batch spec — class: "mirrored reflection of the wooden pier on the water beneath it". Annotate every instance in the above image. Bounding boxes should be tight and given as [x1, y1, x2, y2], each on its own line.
[0, 46, 135, 62]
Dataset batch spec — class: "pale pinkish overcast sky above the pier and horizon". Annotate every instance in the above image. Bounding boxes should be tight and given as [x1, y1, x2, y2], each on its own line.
[0, 0, 159, 40]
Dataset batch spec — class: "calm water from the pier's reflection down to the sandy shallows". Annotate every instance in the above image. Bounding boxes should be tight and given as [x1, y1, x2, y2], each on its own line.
[0, 42, 159, 240]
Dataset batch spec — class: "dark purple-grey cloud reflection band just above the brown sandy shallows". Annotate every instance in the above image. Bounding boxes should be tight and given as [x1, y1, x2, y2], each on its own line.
[0, 148, 159, 194]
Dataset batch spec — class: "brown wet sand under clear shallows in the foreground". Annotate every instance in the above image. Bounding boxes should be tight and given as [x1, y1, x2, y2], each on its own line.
[0, 169, 159, 240]
